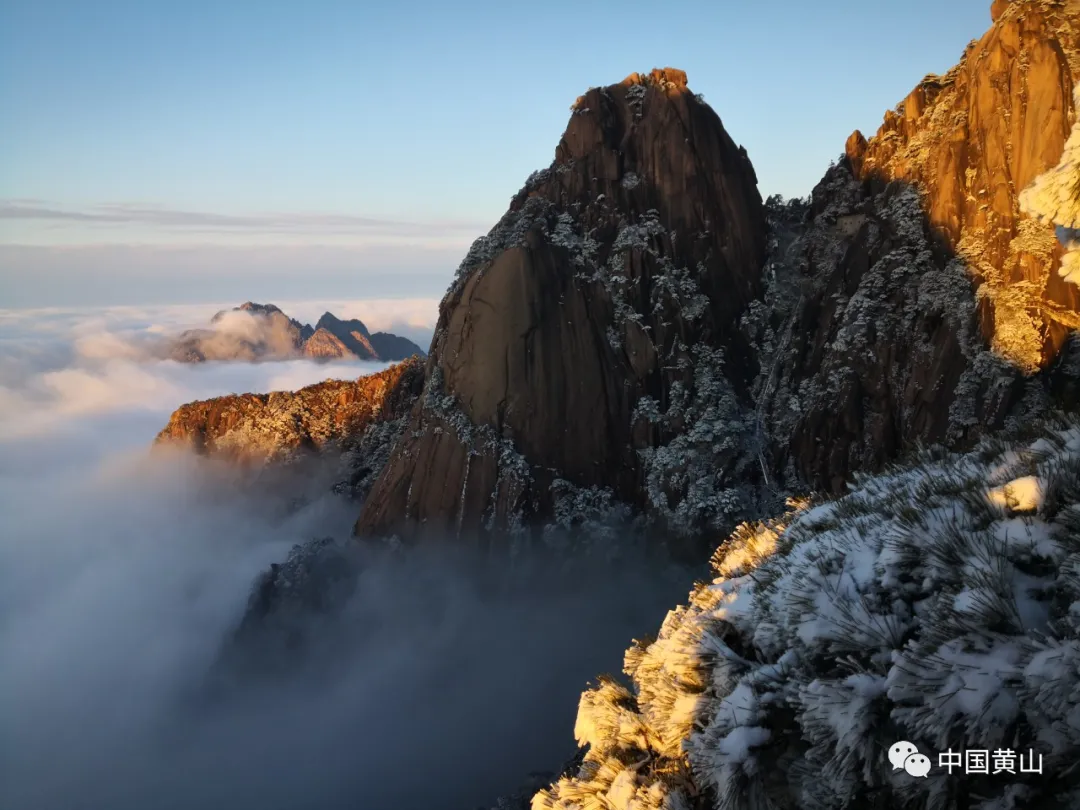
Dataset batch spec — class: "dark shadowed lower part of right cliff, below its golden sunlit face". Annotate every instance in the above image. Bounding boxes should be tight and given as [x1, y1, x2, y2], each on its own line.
[747, 174, 1023, 494]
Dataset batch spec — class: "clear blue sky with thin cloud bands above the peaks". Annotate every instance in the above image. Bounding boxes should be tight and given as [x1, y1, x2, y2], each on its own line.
[0, 0, 990, 306]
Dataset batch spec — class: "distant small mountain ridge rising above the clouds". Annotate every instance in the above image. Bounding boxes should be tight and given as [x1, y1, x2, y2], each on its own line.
[166, 301, 424, 363]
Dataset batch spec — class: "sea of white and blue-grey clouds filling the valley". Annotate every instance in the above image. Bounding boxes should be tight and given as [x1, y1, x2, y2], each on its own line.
[0, 301, 690, 810]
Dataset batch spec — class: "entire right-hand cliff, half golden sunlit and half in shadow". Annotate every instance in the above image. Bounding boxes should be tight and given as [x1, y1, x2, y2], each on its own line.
[747, 0, 1080, 492]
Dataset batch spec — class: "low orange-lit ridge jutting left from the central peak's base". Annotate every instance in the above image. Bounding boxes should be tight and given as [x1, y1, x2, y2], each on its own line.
[156, 359, 423, 495]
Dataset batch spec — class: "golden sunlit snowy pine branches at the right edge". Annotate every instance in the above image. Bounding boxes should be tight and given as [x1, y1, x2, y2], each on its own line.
[1020, 84, 1080, 285]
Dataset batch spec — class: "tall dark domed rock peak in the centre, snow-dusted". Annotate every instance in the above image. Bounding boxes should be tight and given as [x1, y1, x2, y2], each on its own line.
[357, 69, 766, 546]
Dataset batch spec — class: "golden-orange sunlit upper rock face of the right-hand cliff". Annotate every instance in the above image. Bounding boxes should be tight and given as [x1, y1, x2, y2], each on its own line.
[847, 0, 1080, 370]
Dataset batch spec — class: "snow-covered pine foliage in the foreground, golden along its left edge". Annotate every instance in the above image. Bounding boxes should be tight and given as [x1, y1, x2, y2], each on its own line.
[532, 426, 1080, 810]
